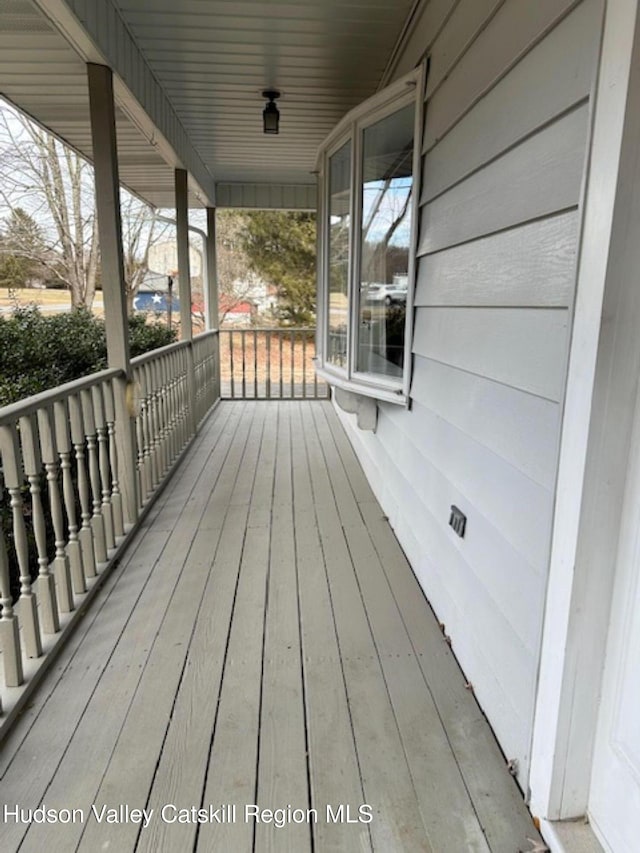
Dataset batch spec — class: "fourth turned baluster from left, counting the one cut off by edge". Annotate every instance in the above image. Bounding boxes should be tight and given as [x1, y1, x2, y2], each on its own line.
[38, 408, 74, 613]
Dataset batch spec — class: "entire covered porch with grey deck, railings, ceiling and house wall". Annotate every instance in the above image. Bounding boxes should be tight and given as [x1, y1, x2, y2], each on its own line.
[0, 0, 616, 853]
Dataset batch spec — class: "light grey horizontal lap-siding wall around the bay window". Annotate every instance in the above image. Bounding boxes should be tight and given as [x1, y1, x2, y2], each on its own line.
[340, 0, 603, 790]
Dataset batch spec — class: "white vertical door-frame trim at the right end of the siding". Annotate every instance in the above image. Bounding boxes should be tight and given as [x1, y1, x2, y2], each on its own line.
[530, 0, 640, 820]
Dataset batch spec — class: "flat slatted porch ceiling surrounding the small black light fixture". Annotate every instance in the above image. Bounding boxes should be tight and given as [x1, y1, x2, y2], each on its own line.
[112, 0, 412, 183]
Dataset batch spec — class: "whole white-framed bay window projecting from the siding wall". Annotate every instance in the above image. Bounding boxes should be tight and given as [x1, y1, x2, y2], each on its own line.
[317, 67, 422, 403]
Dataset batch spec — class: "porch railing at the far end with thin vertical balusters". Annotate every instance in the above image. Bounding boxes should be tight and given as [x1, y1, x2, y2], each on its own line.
[220, 328, 329, 400]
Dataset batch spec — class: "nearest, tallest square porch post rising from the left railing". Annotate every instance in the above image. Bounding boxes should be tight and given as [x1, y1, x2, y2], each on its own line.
[87, 63, 138, 524]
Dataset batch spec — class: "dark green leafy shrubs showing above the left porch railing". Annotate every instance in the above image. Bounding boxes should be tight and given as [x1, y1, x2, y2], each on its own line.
[0, 306, 176, 406]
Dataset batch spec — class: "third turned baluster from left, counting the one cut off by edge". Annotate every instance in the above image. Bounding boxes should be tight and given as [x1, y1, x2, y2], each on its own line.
[20, 415, 60, 634]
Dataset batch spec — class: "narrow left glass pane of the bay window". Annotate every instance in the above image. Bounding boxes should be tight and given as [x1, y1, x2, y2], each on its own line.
[327, 141, 351, 367]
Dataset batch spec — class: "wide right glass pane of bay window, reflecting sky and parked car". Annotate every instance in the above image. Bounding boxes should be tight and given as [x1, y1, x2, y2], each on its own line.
[357, 104, 414, 377]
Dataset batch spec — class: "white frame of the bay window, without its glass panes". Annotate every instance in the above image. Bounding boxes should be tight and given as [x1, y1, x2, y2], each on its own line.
[316, 66, 424, 406]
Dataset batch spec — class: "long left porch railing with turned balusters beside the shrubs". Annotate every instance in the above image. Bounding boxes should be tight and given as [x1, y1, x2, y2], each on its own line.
[0, 332, 220, 718]
